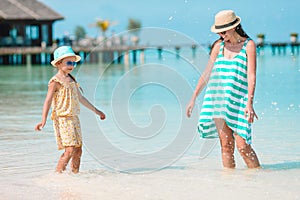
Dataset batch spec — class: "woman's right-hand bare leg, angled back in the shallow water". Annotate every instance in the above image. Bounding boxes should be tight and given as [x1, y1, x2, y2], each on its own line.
[235, 135, 260, 168]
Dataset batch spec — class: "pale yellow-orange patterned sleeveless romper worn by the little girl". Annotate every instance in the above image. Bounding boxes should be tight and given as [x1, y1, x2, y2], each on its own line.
[49, 76, 82, 150]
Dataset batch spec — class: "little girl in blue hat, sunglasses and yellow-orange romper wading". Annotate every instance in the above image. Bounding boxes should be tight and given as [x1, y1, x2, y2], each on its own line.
[35, 46, 105, 173]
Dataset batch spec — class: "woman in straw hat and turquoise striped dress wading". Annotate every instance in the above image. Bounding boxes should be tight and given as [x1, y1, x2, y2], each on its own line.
[187, 10, 260, 168]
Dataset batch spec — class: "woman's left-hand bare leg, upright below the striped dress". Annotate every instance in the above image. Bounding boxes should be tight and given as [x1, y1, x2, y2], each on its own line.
[214, 118, 235, 168]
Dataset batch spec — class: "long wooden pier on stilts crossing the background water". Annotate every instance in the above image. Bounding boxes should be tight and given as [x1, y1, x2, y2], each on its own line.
[0, 43, 300, 66]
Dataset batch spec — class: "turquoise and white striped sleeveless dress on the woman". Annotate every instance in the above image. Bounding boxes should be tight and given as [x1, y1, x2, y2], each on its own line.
[198, 39, 251, 144]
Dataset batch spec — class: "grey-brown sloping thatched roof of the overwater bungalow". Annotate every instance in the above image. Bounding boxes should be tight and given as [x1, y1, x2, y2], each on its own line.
[0, 0, 64, 21]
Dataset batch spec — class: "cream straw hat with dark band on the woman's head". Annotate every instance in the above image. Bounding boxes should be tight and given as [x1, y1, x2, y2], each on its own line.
[210, 10, 241, 33]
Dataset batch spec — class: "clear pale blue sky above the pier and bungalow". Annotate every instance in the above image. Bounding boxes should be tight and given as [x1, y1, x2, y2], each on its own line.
[39, 0, 300, 43]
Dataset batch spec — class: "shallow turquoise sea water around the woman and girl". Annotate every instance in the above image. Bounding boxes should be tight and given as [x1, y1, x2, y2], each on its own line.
[0, 46, 300, 199]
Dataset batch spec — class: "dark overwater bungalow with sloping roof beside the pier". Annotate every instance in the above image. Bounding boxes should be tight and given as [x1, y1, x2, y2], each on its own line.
[0, 0, 64, 64]
